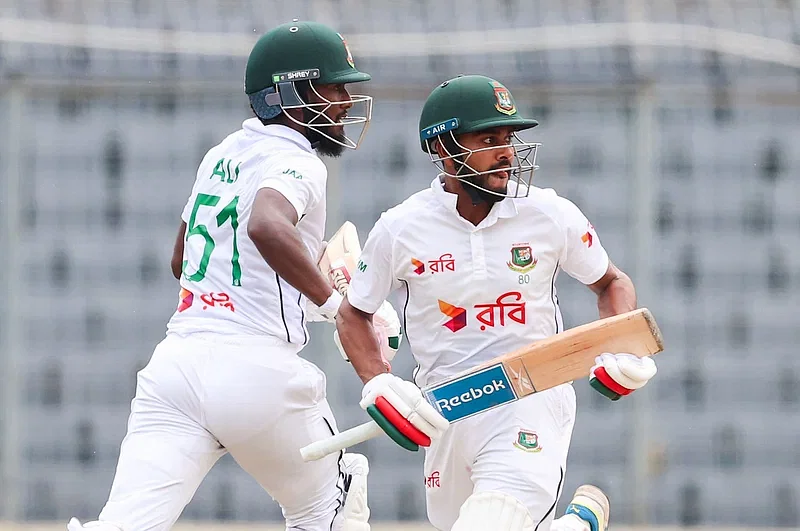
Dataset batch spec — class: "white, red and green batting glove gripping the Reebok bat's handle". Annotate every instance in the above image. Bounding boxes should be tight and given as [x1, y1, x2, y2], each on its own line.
[360, 373, 450, 451]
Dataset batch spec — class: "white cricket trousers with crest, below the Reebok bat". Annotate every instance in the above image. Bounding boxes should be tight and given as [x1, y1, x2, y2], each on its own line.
[425, 384, 576, 531]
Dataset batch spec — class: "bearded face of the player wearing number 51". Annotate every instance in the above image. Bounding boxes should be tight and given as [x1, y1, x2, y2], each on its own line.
[303, 84, 353, 157]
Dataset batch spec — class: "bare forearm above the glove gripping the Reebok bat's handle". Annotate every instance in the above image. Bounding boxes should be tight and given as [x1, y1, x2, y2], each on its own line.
[336, 298, 386, 383]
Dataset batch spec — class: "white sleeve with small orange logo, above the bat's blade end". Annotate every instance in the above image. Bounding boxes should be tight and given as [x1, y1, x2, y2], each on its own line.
[559, 198, 608, 285]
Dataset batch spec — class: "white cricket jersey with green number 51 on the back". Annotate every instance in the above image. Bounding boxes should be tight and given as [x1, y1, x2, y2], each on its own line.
[168, 118, 328, 345]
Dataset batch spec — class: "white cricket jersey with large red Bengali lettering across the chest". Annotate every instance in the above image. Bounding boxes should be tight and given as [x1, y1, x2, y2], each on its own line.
[347, 178, 609, 386]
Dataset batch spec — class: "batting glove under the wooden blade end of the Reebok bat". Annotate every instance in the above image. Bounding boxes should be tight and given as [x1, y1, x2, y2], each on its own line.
[589, 353, 658, 400]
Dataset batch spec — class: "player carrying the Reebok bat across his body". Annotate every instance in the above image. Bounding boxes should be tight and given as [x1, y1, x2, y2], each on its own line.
[336, 75, 656, 531]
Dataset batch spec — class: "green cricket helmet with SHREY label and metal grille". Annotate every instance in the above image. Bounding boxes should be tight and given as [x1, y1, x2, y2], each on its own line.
[244, 20, 372, 149]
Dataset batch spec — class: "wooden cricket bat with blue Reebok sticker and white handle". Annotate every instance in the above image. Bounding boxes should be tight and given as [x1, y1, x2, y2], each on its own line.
[300, 308, 664, 461]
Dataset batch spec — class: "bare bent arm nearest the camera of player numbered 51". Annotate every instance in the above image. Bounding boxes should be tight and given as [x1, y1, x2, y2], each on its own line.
[248, 216, 333, 306]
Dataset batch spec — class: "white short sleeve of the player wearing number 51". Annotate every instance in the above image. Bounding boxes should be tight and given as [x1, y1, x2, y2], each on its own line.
[258, 154, 328, 219]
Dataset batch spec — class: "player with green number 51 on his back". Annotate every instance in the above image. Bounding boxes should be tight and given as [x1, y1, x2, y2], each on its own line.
[68, 21, 399, 531]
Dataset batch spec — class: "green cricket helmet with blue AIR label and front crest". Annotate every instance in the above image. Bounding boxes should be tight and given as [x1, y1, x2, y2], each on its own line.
[419, 75, 541, 197]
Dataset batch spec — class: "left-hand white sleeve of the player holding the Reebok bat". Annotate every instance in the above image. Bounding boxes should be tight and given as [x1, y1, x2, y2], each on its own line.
[347, 215, 400, 313]
